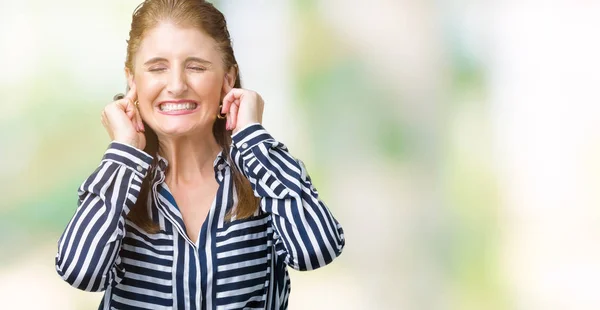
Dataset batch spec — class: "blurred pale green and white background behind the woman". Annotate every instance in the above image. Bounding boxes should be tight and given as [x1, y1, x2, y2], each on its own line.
[0, 0, 600, 310]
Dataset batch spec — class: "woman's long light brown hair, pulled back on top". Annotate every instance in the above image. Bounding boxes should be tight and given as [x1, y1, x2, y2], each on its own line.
[125, 0, 258, 233]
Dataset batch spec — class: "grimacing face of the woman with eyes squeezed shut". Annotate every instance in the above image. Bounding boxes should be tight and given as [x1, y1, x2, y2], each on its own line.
[126, 23, 234, 137]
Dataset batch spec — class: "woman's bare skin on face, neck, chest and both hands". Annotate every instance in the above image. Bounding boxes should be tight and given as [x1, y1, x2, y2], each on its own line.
[101, 22, 264, 241]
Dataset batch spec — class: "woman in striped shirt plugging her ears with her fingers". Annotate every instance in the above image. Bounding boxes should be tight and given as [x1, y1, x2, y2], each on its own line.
[56, 0, 345, 309]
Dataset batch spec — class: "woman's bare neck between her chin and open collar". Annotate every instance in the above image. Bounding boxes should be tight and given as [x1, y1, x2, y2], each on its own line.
[158, 131, 221, 186]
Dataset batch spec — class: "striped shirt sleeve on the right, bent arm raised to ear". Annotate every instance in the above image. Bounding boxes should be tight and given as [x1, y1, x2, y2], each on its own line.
[231, 123, 345, 270]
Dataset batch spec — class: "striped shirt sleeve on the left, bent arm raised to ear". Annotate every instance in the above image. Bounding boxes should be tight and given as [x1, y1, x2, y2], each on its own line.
[55, 142, 153, 292]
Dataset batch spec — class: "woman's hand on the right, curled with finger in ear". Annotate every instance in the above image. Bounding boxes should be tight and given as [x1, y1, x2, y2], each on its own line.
[221, 88, 265, 134]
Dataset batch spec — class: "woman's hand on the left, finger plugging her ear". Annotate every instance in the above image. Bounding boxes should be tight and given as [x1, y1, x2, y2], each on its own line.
[101, 84, 146, 150]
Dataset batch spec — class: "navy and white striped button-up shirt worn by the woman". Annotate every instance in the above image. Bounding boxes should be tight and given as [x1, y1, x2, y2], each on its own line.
[56, 123, 345, 309]
